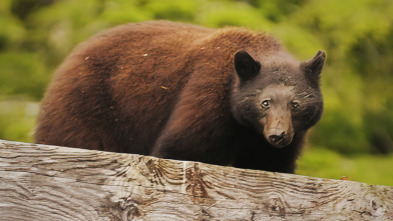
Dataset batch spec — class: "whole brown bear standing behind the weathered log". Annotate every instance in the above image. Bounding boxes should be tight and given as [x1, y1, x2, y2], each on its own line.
[35, 21, 326, 173]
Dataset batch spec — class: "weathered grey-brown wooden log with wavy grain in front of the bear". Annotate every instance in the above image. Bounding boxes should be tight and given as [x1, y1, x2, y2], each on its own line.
[0, 140, 393, 220]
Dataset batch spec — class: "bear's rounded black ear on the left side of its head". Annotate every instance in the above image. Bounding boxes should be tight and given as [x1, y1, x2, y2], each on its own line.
[234, 51, 261, 81]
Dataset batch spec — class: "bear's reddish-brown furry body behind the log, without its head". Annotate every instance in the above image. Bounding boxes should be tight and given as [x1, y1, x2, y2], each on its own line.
[36, 21, 324, 172]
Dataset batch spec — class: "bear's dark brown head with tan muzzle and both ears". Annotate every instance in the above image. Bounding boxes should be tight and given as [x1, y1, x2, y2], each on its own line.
[231, 51, 326, 148]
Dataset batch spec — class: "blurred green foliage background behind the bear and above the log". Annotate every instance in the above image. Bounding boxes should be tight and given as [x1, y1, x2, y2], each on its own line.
[0, 0, 393, 186]
